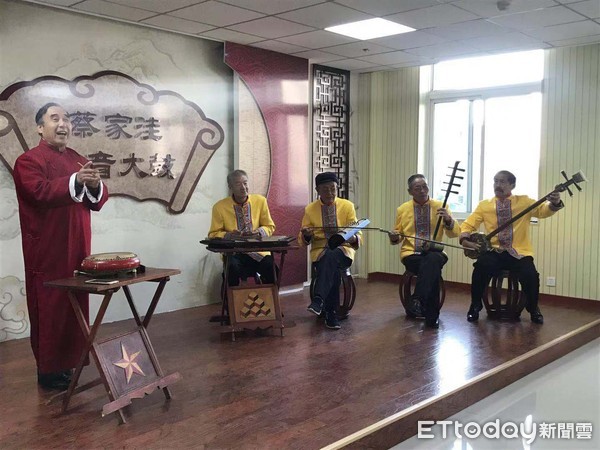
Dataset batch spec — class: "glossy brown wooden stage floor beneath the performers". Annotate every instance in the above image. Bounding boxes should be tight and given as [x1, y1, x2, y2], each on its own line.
[0, 280, 600, 449]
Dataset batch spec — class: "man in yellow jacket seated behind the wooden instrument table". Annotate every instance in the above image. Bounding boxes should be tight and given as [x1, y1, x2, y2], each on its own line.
[208, 170, 276, 286]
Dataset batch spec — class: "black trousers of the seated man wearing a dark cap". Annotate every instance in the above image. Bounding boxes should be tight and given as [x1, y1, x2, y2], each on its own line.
[314, 247, 352, 312]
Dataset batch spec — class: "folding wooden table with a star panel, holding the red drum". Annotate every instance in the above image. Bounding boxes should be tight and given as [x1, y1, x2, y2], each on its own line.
[44, 267, 181, 423]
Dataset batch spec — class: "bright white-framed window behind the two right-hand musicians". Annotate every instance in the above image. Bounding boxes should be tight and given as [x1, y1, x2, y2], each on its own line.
[427, 50, 544, 217]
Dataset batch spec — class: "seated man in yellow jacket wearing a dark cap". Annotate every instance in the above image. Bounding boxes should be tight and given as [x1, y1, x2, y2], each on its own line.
[298, 172, 361, 330]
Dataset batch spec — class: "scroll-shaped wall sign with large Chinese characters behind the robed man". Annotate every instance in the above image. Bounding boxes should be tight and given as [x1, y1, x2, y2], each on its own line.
[0, 71, 225, 214]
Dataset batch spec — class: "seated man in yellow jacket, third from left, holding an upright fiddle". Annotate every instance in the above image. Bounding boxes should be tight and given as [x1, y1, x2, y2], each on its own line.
[390, 173, 460, 328]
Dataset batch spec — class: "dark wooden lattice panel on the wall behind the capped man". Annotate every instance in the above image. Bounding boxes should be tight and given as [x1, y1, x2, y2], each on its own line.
[312, 64, 350, 200]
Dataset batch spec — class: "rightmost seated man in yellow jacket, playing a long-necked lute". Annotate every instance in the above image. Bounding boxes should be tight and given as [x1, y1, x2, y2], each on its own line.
[460, 170, 564, 324]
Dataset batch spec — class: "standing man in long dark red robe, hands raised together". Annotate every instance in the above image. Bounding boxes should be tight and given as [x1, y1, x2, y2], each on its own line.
[13, 103, 108, 390]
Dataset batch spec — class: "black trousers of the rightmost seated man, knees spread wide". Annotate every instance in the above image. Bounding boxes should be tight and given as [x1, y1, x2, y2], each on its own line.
[471, 252, 540, 312]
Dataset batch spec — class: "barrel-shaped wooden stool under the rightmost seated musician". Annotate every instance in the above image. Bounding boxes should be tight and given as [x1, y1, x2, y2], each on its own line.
[483, 270, 527, 320]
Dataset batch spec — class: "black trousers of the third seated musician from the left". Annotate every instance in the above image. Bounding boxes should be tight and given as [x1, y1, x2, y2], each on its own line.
[402, 252, 448, 319]
